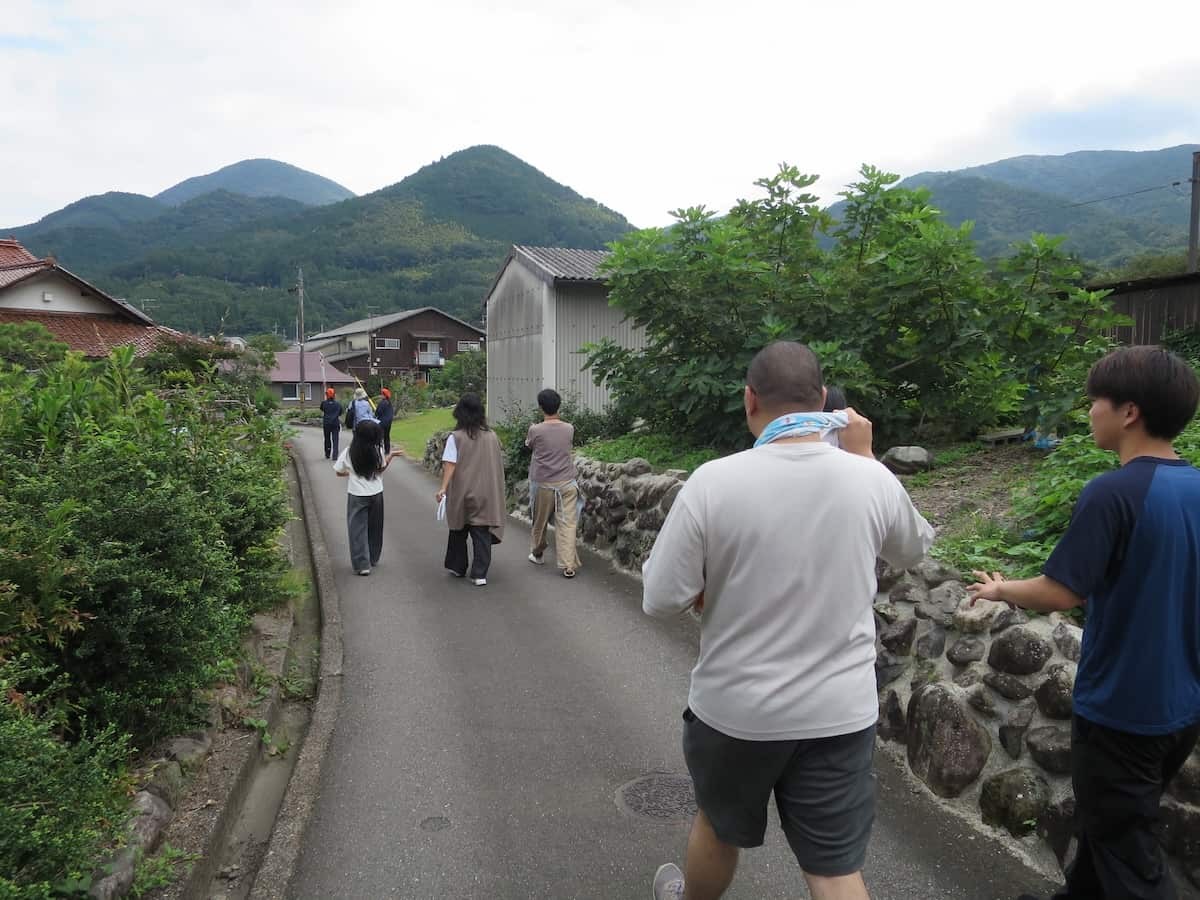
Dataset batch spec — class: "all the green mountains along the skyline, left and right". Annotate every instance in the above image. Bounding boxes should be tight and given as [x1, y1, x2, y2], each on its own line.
[0, 145, 1200, 336]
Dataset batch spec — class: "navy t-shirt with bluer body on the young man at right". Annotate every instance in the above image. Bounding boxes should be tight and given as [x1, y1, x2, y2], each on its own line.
[1042, 456, 1200, 734]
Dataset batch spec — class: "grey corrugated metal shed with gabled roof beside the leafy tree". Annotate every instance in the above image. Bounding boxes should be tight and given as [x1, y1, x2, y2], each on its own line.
[486, 246, 644, 421]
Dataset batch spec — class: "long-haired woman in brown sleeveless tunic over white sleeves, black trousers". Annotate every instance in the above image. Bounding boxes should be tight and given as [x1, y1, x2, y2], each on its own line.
[436, 394, 508, 584]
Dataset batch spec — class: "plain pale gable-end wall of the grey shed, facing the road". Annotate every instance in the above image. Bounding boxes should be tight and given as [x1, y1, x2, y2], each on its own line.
[487, 260, 550, 421]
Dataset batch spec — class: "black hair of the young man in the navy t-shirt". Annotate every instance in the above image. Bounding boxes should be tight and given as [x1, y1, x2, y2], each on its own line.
[1087, 346, 1200, 440]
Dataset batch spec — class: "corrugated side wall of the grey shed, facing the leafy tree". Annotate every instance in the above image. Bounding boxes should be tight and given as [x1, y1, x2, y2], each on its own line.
[553, 282, 646, 412]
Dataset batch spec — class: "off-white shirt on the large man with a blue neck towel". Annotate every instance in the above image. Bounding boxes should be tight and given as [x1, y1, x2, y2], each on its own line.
[642, 442, 934, 740]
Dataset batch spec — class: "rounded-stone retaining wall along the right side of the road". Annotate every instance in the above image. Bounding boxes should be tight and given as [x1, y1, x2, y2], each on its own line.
[425, 436, 1200, 887]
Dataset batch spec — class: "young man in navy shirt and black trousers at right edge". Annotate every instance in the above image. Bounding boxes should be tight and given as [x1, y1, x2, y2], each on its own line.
[971, 347, 1200, 900]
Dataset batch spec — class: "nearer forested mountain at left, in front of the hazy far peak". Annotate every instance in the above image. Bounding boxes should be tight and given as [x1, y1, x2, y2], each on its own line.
[0, 146, 631, 336]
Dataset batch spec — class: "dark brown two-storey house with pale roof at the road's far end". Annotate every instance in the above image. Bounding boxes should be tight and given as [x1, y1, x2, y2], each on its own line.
[305, 306, 486, 382]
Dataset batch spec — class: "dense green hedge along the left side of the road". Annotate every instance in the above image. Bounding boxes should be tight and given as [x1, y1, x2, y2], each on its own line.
[0, 326, 288, 898]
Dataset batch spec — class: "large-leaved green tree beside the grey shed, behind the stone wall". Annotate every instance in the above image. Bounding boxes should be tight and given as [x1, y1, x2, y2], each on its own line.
[587, 166, 1117, 448]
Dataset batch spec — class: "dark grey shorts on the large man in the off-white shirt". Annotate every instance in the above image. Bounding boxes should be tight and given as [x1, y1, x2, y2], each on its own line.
[683, 709, 875, 877]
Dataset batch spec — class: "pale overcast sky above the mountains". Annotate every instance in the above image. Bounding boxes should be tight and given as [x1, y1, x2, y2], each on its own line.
[0, 0, 1200, 227]
